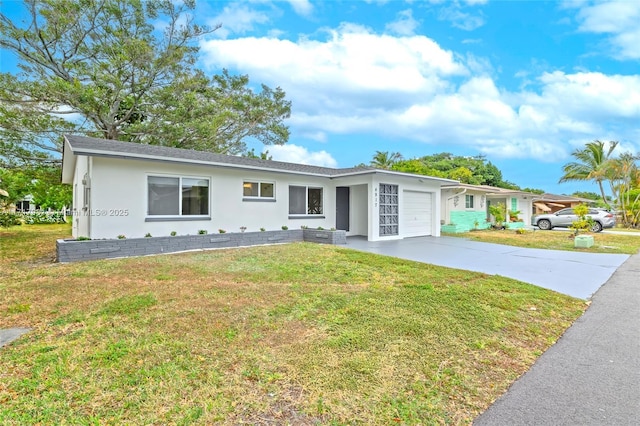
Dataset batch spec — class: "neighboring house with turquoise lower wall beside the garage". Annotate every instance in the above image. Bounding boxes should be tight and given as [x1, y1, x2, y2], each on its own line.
[440, 183, 536, 233]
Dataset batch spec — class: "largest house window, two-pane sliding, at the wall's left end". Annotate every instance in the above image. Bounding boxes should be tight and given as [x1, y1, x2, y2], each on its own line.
[147, 176, 209, 216]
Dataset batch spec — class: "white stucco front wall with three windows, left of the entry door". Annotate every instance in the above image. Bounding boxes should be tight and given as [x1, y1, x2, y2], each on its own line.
[85, 157, 350, 239]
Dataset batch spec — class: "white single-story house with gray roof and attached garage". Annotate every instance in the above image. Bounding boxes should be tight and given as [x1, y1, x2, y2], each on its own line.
[62, 136, 455, 241]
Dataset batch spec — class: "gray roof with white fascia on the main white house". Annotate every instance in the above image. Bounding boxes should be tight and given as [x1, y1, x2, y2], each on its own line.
[63, 135, 456, 183]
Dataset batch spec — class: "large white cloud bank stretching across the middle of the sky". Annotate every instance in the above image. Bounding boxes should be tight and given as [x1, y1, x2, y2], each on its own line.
[202, 24, 640, 161]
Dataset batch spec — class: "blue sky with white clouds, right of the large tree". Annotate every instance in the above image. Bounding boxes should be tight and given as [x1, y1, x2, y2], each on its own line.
[2, 0, 640, 193]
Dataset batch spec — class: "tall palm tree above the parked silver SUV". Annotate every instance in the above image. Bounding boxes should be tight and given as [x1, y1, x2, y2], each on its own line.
[559, 140, 618, 207]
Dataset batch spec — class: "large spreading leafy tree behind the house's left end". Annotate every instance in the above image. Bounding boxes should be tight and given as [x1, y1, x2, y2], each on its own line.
[0, 0, 290, 165]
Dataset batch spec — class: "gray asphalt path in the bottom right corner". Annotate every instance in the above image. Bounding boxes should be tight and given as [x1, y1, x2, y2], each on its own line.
[474, 254, 640, 426]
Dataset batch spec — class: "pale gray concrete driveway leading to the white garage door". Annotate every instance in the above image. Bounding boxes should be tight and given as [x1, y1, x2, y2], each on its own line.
[347, 237, 629, 299]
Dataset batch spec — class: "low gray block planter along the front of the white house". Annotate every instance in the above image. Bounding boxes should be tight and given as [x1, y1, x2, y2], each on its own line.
[56, 229, 346, 262]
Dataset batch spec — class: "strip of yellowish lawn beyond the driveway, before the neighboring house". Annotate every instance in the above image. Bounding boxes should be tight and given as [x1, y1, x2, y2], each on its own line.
[447, 229, 640, 254]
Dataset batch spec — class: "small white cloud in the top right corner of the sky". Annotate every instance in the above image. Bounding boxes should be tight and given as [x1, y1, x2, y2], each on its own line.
[577, 0, 640, 60]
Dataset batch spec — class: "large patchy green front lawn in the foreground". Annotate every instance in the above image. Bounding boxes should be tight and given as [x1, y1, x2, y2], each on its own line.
[0, 226, 586, 425]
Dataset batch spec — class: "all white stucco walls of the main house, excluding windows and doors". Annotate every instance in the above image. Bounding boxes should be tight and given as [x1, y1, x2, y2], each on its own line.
[73, 156, 441, 241]
